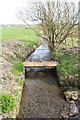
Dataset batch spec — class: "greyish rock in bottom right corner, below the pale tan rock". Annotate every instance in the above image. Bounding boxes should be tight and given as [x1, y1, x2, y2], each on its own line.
[69, 103, 79, 117]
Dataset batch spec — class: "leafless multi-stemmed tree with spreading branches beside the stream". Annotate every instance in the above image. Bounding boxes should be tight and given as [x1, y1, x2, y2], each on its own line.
[18, 0, 78, 58]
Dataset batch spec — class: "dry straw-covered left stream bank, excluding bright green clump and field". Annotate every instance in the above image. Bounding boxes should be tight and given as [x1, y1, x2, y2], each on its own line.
[0, 40, 40, 118]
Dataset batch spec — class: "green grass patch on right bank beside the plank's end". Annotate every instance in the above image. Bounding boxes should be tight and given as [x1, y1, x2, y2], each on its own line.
[58, 54, 79, 77]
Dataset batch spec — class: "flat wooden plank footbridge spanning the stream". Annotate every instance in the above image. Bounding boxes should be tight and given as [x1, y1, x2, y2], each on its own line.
[23, 61, 58, 68]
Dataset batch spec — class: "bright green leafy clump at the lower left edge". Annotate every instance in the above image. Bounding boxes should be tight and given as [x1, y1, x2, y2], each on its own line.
[0, 94, 15, 113]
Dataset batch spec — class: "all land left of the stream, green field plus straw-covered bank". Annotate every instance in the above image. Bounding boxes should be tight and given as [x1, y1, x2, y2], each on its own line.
[0, 27, 40, 118]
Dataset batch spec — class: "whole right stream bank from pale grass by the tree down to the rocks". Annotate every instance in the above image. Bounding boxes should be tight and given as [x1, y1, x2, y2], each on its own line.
[53, 38, 80, 89]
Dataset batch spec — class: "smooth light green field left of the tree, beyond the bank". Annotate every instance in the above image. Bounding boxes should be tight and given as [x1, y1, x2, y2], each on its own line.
[2, 26, 39, 45]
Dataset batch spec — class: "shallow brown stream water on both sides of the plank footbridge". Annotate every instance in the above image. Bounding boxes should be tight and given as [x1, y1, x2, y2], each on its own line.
[19, 44, 66, 118]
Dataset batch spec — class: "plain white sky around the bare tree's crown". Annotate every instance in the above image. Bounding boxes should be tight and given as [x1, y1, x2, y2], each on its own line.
[0, 0, 79, 24]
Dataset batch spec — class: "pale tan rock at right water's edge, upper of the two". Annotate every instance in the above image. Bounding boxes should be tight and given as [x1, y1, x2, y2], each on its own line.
[64, 90, 79, 100]
